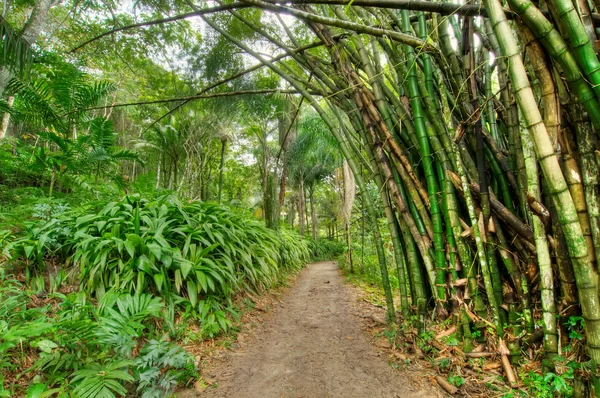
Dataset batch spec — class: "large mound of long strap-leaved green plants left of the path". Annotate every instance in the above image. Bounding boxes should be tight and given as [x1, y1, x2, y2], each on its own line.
[7, 195, 309, 337]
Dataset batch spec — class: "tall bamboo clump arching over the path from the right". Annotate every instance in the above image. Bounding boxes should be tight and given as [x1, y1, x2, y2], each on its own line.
[71, 0, 600, 395]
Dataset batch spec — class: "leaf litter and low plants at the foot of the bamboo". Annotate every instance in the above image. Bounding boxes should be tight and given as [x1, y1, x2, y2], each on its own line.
[340, 261, 590, 398]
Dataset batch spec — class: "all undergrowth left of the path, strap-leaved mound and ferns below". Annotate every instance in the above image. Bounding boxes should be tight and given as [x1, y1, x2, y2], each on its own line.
[0, 195, 310, 398]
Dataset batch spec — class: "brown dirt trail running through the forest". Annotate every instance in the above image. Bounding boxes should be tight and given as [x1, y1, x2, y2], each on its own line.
[200, 262, 437, 398]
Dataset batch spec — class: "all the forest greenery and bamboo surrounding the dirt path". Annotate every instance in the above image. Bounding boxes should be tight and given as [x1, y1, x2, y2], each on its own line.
[0, 0, 600, 397]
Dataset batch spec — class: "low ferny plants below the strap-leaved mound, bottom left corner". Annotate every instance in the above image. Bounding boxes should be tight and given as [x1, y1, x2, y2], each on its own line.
[0, 272, 197, 398]
